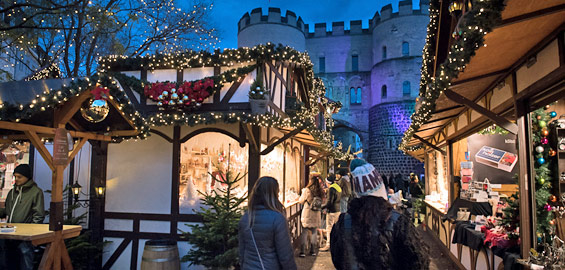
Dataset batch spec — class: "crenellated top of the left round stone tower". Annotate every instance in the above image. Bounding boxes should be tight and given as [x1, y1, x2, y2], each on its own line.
[237, 7, 307, 33]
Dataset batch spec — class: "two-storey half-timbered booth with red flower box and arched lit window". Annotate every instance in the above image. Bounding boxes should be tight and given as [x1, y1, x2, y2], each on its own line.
[94, 44, 345, 269]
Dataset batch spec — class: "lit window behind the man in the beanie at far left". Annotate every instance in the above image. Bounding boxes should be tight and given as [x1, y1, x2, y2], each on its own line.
[0, 142, 29, 202]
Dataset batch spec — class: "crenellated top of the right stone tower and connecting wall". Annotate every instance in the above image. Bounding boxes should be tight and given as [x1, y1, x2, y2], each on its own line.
[304, 0, 429, 38]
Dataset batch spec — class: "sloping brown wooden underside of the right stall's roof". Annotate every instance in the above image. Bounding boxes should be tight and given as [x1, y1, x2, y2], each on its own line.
[401, 0, 565, 158]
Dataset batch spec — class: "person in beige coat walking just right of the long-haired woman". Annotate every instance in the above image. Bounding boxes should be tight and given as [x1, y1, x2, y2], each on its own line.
[298, 176, 324, 258]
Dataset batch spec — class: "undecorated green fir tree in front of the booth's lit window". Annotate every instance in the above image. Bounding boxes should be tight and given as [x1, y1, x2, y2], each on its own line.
[181, 147, 247, 269]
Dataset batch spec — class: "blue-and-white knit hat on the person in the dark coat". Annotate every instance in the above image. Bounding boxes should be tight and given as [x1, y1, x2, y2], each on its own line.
[349, 159, 387, 199]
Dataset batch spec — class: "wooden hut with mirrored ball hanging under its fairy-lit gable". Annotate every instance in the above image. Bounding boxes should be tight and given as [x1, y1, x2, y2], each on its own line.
[0, 76, 146, 269]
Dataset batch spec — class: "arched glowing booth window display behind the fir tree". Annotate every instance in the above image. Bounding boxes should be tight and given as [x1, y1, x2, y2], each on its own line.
[179, 132, 248, 214]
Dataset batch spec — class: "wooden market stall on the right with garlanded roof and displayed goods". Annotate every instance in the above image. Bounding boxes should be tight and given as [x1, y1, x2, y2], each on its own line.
[399, 0, 565, 269]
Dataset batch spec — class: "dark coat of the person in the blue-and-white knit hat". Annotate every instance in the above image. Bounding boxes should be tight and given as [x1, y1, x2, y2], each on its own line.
[330, 196, 429, 270]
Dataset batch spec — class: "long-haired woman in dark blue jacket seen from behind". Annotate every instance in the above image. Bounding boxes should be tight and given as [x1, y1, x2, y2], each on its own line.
[238, 176, 297, 270]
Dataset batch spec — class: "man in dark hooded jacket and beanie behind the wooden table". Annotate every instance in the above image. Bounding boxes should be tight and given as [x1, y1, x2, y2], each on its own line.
[0, 164, 45, 270]
